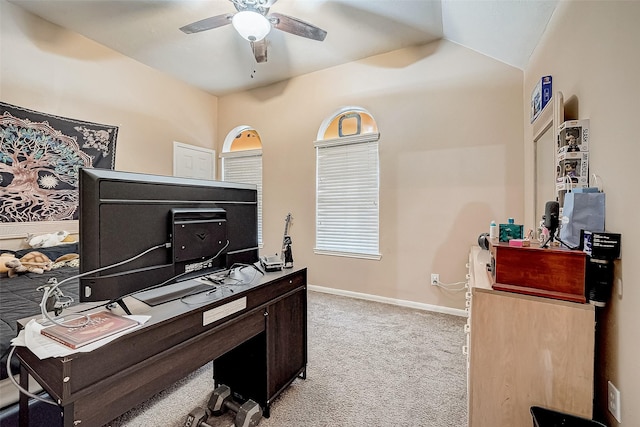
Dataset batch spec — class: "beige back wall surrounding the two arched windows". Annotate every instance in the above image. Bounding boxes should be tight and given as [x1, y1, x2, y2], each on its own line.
[218, 41, 523, 309]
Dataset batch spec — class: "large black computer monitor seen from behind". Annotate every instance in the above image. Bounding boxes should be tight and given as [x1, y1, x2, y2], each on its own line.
[79, 169, 258, 303]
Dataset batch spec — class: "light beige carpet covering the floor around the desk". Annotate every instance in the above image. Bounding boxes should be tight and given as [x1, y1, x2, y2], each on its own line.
[104, 291, 467, 427]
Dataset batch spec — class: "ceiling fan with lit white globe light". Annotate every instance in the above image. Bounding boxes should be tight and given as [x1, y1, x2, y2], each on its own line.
[180, 0, 327, 63]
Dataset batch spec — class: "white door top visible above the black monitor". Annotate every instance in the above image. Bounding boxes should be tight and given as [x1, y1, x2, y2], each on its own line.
[173, 141, 216, 179]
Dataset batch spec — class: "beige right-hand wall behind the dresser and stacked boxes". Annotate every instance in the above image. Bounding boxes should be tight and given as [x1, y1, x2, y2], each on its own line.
[524, 1, 640, 426]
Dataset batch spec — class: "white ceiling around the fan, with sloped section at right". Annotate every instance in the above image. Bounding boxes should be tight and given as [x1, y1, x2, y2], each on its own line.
[8, 0, 558, 95]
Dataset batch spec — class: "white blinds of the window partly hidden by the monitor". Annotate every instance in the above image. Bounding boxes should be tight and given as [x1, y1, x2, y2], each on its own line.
[222, 151, 262, 245]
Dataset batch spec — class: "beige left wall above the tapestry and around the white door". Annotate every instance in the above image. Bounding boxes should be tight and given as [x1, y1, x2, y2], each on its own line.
[0, 0, 218, 175]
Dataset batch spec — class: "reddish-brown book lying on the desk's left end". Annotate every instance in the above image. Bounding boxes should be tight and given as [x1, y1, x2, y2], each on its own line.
[40, 310, 139, 349]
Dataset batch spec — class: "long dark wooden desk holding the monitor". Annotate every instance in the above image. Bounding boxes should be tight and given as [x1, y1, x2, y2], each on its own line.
[16, 269, 307, 426]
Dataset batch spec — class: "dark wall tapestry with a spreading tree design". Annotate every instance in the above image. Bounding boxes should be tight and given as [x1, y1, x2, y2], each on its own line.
[0, 102, 118, 222]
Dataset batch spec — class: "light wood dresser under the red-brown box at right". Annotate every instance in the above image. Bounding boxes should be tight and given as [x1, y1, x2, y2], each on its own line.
[468, 247, 595, 427]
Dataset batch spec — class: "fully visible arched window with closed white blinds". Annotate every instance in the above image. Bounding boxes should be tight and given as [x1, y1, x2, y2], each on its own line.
[314, 107, 380, 259]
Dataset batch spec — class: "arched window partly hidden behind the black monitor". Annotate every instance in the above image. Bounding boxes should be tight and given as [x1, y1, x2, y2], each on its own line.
[220, 126, 262, 246]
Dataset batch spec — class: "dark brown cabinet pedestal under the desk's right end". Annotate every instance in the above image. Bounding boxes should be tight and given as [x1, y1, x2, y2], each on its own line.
[213, 270, 307, 417]
